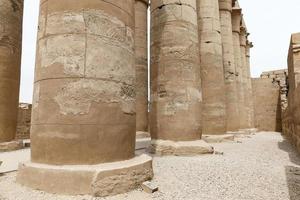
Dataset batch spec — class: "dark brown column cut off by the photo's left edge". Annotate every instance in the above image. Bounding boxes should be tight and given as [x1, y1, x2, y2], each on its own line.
[0, 0, 23, 143]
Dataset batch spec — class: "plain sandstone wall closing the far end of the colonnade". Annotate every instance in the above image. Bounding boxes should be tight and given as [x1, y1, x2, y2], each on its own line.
[252, 77, 281, 132]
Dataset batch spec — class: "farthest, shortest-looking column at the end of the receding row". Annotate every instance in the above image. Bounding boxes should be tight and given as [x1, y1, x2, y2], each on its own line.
[246, 40, 255, 128]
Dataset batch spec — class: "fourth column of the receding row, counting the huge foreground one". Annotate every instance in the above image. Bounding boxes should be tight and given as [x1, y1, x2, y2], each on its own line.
[219, 0, 240, 131]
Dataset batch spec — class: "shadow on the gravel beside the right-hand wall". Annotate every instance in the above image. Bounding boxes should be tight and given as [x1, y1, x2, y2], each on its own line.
[278, 138, 300, 200]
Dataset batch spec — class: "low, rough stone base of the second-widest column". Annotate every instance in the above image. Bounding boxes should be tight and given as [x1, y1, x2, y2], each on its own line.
[149, 140, 214, 156]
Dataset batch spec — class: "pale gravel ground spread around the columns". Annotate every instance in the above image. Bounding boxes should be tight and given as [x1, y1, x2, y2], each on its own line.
[0, 132, 300, 200]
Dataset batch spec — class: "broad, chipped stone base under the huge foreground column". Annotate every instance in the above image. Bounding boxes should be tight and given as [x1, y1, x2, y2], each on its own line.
[17, 155, 153, 197]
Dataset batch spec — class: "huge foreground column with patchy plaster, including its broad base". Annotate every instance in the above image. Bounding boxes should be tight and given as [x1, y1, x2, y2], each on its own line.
[17, 0, 152, 196]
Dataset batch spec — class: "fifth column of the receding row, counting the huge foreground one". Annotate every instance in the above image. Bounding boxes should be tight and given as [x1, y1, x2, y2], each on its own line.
[232, 7, 246, 128]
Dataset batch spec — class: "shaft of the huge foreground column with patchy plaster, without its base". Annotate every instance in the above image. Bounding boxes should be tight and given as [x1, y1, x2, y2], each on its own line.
[31, 0, 136, 164]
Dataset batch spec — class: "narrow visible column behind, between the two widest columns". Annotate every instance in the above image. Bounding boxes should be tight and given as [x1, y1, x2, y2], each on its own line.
[135, 0, 148, 133]
